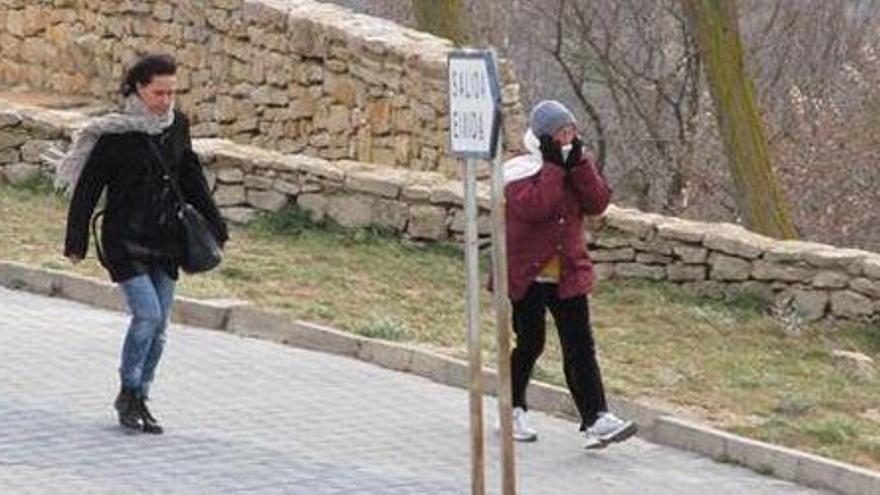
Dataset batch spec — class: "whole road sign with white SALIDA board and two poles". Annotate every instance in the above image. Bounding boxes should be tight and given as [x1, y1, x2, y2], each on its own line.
[448, 50, 516, 495]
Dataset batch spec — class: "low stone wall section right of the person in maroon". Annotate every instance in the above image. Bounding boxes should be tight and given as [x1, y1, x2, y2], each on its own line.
[590, 207, 880, 321]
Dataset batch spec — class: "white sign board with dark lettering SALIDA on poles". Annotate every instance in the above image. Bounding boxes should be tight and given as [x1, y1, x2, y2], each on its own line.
[449, 50, 501, 159]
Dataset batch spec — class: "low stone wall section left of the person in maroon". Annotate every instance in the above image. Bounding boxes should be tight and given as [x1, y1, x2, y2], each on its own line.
[0, 94, 489, 241]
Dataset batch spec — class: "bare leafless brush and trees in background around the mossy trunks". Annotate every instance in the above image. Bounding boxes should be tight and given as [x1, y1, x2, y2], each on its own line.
[324, 0, 880, 250]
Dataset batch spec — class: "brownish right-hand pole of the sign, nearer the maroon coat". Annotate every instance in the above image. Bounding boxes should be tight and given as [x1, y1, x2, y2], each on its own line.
[492, 131, 516, 495]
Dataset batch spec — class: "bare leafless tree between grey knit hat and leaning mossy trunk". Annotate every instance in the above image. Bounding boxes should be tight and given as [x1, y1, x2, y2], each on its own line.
[539, 0, 701, 212]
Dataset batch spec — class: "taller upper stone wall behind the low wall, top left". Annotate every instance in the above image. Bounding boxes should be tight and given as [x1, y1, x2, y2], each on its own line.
[0, 0, 523, 177]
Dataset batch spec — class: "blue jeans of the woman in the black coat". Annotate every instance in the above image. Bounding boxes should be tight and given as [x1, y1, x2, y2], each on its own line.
[119, 267, 175, 397]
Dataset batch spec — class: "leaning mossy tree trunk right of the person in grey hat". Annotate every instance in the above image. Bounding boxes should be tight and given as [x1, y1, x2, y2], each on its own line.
[682, 0, 797, 239]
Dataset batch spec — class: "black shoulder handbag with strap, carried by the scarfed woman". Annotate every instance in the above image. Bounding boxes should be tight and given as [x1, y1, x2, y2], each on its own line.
[146, 137, 223, 273]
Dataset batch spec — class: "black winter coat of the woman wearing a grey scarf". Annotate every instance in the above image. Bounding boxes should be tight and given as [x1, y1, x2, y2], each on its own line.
[64, 112, 228, 282]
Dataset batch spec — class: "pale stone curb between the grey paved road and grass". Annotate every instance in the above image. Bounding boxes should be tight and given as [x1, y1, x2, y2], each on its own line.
[0, 260, 880, 495]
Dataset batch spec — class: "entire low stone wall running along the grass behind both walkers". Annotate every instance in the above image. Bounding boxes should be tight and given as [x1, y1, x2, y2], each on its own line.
[0, 100, 880, 321]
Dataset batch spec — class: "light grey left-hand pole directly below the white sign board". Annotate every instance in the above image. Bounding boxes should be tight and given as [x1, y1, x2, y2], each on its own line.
[464, 159, 486, 495]
